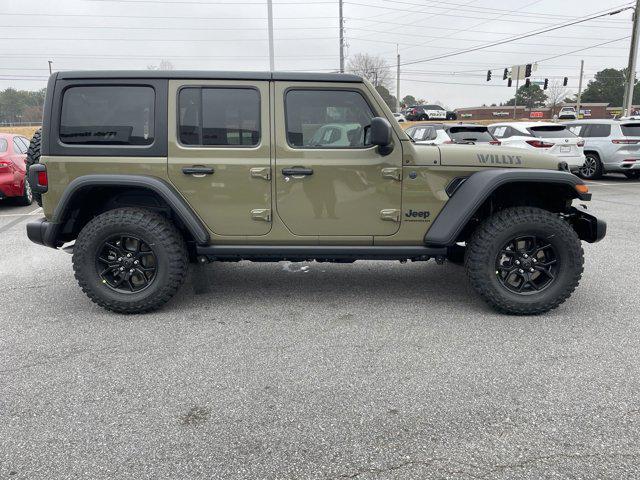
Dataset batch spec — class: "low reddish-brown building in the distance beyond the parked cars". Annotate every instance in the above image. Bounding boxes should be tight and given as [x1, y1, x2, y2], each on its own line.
[455, 103, 640, 122]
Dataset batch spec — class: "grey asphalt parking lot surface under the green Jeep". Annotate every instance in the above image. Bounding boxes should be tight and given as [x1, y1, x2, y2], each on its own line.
[0, 176, 640, 479]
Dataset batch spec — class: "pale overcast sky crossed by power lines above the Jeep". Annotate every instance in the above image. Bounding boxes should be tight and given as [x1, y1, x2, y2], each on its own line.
[0, 0, 631, 108]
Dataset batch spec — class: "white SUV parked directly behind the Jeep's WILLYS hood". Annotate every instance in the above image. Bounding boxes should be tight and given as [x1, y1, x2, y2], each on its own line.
[489, 122, 585, 173]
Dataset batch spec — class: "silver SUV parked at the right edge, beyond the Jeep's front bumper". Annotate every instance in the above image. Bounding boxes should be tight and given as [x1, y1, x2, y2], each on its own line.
[566, 120, 640, 179]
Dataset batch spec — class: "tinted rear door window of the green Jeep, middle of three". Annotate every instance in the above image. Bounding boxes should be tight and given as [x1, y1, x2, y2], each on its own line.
[178, 87, 260, 146]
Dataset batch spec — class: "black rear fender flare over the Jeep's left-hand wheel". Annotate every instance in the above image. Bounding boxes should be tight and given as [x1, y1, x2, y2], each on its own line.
[51, 175, 209, 244]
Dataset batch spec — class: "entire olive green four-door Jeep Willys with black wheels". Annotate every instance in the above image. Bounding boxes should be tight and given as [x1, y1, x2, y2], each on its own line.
[27, 71, 606, 314]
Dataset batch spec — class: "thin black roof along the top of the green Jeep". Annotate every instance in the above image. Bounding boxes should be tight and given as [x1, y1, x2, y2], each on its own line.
[54, 70, 362, 83]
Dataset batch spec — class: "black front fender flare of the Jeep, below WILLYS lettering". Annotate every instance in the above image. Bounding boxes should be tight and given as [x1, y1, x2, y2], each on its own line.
[424, 168, 591, 246]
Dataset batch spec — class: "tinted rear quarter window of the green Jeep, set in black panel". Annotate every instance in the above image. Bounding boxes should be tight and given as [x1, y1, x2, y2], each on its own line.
[60, 85, 155, 145]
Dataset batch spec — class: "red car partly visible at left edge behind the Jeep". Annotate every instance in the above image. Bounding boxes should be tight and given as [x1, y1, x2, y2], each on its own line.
[0, 133, 33, 205]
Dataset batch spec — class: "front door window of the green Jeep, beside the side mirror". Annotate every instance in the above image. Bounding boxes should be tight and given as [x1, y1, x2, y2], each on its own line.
[285, 90, 374, 148]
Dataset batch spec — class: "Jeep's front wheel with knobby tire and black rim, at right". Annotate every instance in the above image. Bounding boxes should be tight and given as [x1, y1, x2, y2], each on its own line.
[465, 207, 584, 315]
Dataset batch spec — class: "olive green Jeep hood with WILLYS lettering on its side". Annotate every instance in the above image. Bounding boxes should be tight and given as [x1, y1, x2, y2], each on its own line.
[415, 144, 560, 170]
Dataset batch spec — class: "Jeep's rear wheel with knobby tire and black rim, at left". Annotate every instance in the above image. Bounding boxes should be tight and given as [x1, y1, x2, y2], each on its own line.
[73, 208, 188, 313]
